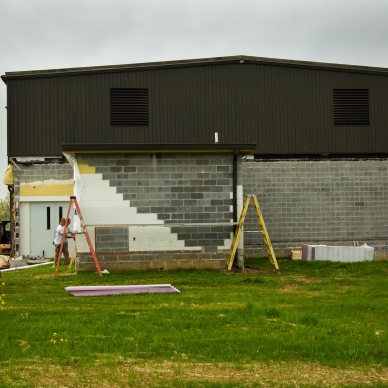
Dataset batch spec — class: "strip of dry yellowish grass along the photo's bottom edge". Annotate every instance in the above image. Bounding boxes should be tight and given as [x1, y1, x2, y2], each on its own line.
[2, 356, 388, 388]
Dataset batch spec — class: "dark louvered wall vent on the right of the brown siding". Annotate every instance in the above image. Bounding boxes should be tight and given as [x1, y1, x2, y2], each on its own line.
[333, 89, 369, 125]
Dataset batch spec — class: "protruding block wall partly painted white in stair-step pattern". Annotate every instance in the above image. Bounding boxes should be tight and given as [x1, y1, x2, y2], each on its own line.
[75, 152, 241, 271]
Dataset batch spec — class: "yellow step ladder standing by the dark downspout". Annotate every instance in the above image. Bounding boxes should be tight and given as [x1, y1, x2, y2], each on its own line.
[226, 195, 280, 273]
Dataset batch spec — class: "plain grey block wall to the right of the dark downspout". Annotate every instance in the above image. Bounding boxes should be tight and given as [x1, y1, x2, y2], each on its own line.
[242, 159, 388, 256]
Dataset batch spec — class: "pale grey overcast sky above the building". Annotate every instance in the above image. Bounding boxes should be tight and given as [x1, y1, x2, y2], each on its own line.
[0, 0, 388, 198]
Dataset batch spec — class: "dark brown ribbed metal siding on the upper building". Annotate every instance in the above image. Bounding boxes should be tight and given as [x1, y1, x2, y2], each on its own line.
[8, 63, 388, 156]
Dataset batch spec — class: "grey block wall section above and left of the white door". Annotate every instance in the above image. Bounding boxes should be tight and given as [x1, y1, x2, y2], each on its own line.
[14, 163, 74, 256]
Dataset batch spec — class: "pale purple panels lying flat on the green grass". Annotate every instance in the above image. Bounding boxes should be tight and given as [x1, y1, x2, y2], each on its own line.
[65, 284, 180, 296]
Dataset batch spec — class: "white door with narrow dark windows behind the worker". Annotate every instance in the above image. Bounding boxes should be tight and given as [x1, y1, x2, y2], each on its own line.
[30, 202, 74, 258]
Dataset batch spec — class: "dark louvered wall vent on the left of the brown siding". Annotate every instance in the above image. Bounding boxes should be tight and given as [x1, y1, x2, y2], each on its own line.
[110, 88, 148, 127]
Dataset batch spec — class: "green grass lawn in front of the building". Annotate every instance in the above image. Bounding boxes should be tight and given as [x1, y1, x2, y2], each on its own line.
[0, 259, 388, 387]
